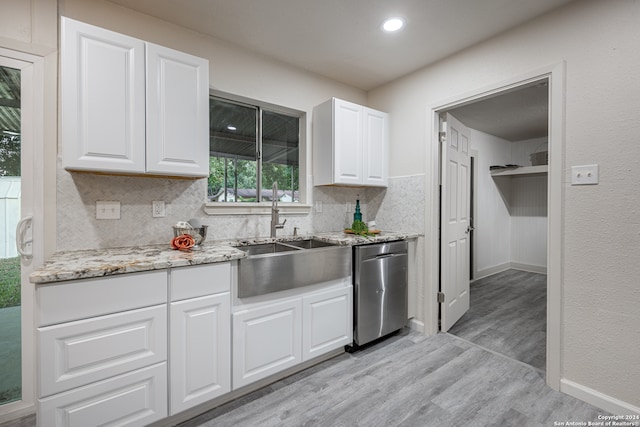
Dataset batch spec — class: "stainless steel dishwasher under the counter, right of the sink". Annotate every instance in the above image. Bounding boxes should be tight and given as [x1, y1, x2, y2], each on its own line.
[353, 241, 408, 346]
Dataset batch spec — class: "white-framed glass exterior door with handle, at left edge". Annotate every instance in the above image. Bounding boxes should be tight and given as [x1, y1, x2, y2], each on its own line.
[0, 48, 44, 423]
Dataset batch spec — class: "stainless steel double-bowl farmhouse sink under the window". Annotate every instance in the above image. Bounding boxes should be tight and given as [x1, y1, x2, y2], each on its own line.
[238, 239, 352, 298]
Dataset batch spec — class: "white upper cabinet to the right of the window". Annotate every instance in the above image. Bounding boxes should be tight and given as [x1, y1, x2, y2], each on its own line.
[313, 98, 389, 187]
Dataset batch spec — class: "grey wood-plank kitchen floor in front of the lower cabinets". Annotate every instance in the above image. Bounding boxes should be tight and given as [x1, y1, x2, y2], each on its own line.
[180, 332, 605, 427]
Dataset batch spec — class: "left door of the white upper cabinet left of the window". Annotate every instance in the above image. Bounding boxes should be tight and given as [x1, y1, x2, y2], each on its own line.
[61, 18, 145, 173]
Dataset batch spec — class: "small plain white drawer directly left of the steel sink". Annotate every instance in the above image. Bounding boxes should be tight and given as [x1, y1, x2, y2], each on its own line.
[169, 262, 231, 301]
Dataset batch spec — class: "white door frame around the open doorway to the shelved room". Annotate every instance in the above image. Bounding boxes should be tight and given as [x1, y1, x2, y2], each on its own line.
[423, 61, 566, 390]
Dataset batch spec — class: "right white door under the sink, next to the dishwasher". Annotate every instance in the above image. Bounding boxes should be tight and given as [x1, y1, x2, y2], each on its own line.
[302, 286, 353, 361]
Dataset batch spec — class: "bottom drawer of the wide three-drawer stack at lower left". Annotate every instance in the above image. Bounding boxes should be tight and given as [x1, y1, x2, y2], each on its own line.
[38, 363, 167, 427]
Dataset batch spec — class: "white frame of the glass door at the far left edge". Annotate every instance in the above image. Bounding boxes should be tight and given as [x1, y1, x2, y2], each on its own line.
[0, 47, 46, 422]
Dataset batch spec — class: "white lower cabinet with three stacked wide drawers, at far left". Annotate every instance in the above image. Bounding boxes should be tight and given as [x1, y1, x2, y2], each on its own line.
[36, 272, 168, 427]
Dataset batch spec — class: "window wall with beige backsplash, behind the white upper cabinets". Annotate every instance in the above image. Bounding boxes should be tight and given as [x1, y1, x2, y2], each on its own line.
[56, 0, 367, 250]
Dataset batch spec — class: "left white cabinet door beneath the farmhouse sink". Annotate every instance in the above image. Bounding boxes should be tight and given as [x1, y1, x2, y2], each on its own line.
[233, 298, 302, 389]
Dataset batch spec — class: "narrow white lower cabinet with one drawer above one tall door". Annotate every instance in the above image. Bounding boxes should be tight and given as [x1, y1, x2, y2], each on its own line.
[169, 262, 231, 415]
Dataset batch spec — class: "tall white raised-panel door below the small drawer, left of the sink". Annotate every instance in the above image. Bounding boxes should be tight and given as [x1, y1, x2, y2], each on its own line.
[169, 292, 231, 415]
